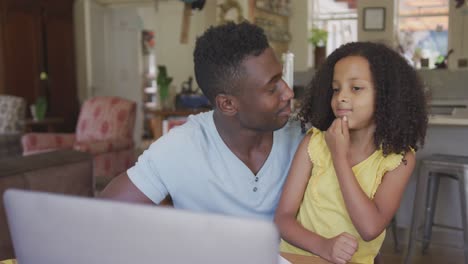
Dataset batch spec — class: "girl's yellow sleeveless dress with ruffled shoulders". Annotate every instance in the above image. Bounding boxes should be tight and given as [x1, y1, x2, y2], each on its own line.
[280, 128, 403, 263]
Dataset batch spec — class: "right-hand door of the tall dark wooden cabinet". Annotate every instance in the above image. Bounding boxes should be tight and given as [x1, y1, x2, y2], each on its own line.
[42, 0, 79, 132]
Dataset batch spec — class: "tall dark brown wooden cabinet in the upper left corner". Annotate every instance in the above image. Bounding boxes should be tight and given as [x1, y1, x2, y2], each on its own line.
[0, 0, 79, 131]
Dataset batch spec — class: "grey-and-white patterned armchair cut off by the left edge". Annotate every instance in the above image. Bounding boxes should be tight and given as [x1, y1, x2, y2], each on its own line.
[0, 95, 26, 158]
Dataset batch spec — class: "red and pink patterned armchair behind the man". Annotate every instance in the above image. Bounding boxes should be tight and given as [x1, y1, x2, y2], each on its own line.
[21, 97, 136, 189]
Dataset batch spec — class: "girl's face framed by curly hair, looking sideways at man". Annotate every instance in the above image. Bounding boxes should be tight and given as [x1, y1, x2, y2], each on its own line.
[331, 56, 375, 130]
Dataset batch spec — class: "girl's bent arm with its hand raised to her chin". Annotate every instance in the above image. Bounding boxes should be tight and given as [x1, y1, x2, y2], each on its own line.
[326, 119, 416, 241]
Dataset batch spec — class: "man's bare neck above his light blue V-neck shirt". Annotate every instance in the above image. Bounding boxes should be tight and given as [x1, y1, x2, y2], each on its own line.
[213, 111, 273, 174]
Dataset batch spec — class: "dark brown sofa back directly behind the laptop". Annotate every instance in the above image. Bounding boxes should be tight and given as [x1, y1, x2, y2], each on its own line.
[0, 150, 93, 260]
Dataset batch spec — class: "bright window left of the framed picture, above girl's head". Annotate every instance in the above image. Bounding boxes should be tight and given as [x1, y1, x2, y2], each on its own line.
[309, 0, 357, 55]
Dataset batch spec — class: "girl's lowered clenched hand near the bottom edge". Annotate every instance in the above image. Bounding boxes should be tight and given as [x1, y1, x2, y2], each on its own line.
[320, 232, 358, 264]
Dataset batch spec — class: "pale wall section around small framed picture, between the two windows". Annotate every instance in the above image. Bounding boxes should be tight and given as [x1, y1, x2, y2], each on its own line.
[357, 0, 397, 46]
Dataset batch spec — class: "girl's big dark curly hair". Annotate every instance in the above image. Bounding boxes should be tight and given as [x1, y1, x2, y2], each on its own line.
[298, 42, 427, 155]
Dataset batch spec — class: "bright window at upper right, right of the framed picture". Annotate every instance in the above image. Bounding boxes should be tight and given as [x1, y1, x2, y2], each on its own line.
[398, 0, 449, 68]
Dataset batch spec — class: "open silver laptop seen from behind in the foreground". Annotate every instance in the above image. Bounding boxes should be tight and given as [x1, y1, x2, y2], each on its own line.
[4, 190, 279, 264]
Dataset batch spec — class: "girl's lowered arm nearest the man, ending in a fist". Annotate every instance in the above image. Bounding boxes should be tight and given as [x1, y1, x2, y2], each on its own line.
[275, 134, 357, 263]
